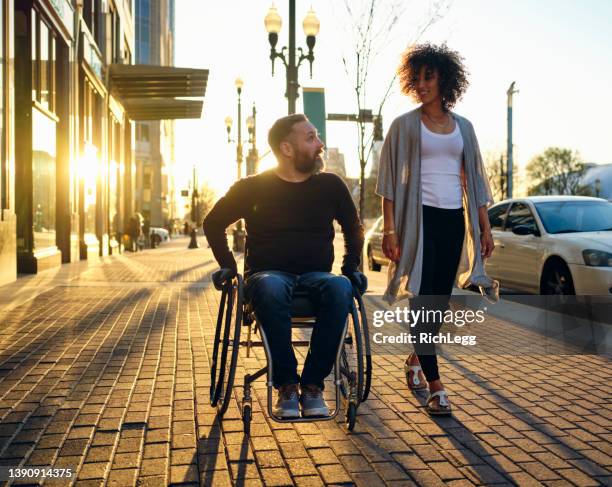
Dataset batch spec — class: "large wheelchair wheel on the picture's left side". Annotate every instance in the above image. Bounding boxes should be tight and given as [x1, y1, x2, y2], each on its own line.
[210, 276, 243, 416]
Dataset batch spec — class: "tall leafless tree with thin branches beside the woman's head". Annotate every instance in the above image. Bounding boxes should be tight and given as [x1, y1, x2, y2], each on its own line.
[342, 0, 450, 218]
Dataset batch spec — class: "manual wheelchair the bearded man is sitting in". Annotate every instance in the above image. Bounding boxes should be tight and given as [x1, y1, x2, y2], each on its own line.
[210, 274, 372, 436]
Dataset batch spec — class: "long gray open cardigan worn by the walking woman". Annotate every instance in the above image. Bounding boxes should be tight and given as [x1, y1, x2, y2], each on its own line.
[376, 107, 499, 304]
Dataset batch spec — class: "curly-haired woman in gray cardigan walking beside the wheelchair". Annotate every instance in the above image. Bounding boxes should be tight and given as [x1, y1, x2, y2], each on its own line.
[376, 44, 498, 415]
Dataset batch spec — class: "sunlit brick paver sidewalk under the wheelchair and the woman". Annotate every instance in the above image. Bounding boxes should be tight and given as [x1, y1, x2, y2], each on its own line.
[0, 239, 612, 487]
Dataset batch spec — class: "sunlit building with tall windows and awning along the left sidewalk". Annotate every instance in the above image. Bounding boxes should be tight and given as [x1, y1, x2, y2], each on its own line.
[0, 0, 208, 285]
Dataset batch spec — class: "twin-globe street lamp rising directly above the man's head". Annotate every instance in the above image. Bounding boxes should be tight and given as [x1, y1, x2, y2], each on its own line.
[264, 0, 321, 115]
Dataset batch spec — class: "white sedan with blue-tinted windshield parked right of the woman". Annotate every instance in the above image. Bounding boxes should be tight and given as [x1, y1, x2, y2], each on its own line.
[485, 196, 612, 296]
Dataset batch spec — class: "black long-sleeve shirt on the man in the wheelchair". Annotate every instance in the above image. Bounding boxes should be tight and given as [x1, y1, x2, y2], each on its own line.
[204, 170, 363, 277]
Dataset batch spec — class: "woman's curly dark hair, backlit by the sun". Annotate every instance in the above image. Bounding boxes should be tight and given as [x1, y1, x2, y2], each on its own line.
[397, 43, 469, 111]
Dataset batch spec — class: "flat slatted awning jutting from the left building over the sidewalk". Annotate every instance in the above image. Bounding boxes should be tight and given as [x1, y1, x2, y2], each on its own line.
[109, 64, 208, 120]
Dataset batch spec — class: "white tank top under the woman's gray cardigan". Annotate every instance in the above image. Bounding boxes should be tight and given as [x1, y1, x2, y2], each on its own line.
[421, 121, 463, 209]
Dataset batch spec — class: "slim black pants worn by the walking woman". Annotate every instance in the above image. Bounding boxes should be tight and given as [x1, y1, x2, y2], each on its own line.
[410, 205, 465, 382]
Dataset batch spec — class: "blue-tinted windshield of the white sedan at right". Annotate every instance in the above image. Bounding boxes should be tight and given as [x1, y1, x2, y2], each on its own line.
[535, 201, 612, 233]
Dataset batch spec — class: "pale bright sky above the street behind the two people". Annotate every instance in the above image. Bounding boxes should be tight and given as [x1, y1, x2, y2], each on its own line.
[175, 0, 612, 195]
